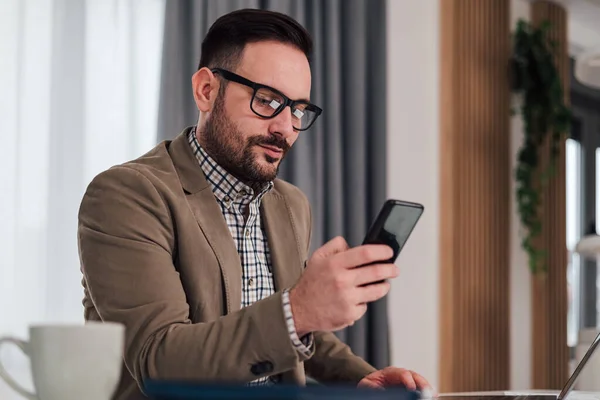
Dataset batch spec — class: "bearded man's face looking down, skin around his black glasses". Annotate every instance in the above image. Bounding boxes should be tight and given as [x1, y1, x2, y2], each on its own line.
[199, 42, 311, 184]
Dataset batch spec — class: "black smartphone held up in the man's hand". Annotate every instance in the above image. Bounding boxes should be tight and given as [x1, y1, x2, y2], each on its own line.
[363, 199, 424, 263]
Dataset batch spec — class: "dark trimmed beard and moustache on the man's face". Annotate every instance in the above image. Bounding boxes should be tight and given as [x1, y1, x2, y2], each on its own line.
[198, 94, 290, 187]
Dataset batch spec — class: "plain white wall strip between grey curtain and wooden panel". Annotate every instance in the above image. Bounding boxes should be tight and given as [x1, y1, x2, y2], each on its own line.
[387, 0, 439, 388]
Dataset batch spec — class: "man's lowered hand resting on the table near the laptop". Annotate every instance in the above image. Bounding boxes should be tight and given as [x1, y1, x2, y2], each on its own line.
[358, 367, 437, 397]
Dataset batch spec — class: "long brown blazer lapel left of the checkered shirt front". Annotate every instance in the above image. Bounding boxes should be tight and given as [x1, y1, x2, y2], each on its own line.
[169, 128, 242, 313]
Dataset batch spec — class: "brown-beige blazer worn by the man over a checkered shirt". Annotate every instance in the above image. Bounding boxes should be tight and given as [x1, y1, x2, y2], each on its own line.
[78, 128, 375, 400]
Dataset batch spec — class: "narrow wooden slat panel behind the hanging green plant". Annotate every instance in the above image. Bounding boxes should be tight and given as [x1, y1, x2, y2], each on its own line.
[531, 1, 569, 389]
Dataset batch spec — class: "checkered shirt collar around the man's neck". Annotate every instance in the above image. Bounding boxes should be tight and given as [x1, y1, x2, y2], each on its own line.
[188, 127, 274, 206]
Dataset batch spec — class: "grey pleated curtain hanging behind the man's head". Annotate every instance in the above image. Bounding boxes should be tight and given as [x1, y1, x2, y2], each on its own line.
[158, 0, 390, 368]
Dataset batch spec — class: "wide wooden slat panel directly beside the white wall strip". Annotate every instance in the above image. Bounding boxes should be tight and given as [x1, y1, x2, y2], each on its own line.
[439, 0, 511, 392]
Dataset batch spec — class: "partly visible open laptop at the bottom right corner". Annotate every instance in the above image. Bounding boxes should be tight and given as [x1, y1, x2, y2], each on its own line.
[439, 333, 600, 400]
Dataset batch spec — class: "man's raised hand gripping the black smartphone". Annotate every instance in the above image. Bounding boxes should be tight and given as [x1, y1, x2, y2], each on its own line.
[290, 237, 398, 337]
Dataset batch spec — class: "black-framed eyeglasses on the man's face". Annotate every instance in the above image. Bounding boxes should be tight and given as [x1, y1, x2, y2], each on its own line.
[211, 68, 323, 131]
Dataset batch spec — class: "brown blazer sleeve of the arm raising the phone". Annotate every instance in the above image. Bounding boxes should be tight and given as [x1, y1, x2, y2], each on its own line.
[78, 166, 312, 391]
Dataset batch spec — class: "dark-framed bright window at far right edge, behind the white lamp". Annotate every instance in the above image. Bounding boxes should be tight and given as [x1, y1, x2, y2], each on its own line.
[565, 60, 600, 368]
